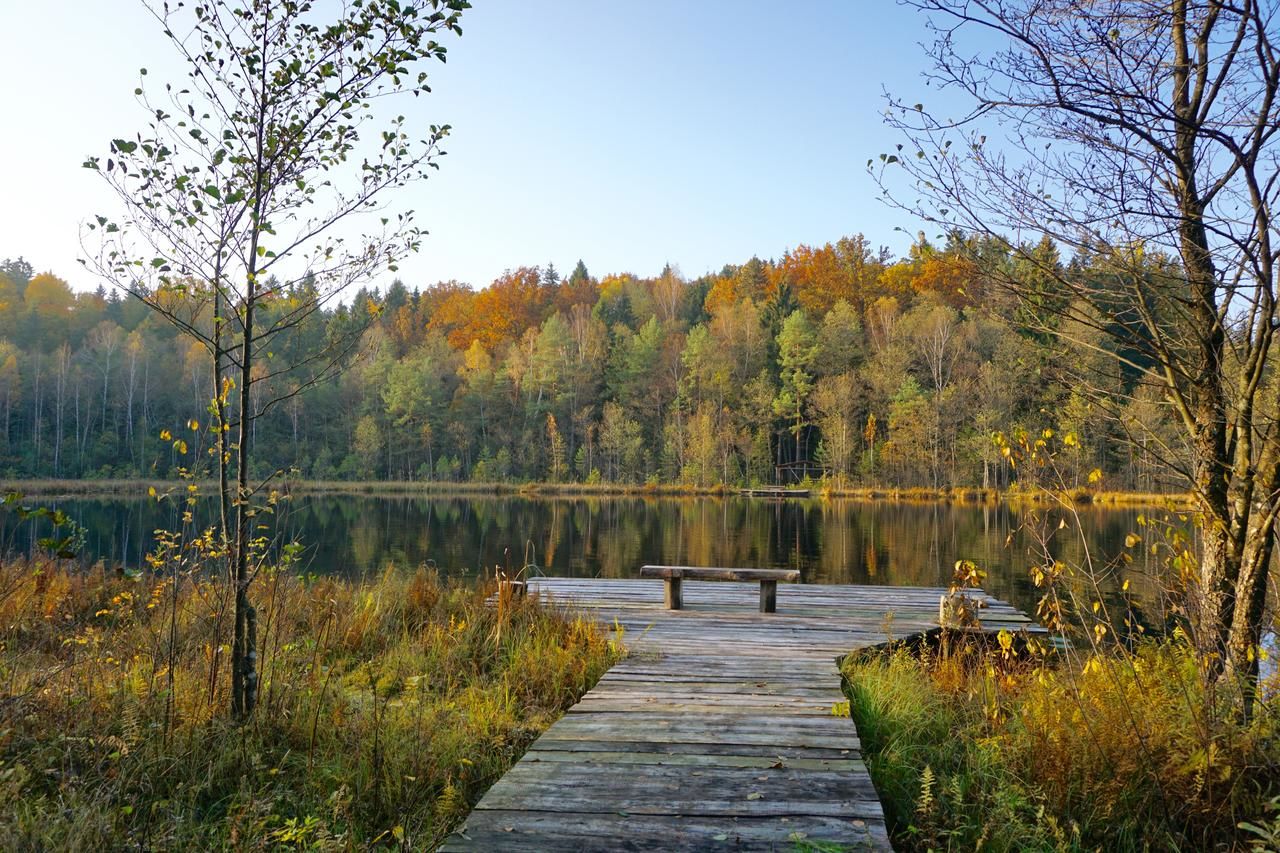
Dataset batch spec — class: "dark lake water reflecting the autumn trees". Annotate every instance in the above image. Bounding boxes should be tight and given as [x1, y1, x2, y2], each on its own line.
[0, 494, 1166, 622]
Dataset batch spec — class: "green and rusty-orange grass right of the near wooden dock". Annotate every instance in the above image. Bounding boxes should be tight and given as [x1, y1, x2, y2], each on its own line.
[844, 639, 1280, 850]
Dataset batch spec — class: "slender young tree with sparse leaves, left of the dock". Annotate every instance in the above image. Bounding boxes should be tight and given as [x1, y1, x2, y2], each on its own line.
[84, 0, 468, 719]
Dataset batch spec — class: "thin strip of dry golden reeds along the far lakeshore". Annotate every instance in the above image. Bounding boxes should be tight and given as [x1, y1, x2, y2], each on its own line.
[0, 479, 1190, 507]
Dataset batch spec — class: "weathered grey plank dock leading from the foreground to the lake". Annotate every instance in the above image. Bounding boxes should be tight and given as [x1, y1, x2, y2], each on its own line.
[442, 578, 1029, 850]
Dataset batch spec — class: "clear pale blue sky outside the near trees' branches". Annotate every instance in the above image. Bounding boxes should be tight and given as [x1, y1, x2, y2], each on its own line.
[0, 0, 936, 288]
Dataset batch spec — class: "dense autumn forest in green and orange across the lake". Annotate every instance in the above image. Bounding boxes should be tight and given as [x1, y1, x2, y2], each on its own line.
[0, 233, 1175, 492]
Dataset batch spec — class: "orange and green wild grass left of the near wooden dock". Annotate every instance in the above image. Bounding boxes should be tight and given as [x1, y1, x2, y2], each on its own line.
[0, 562, 620, 849]
